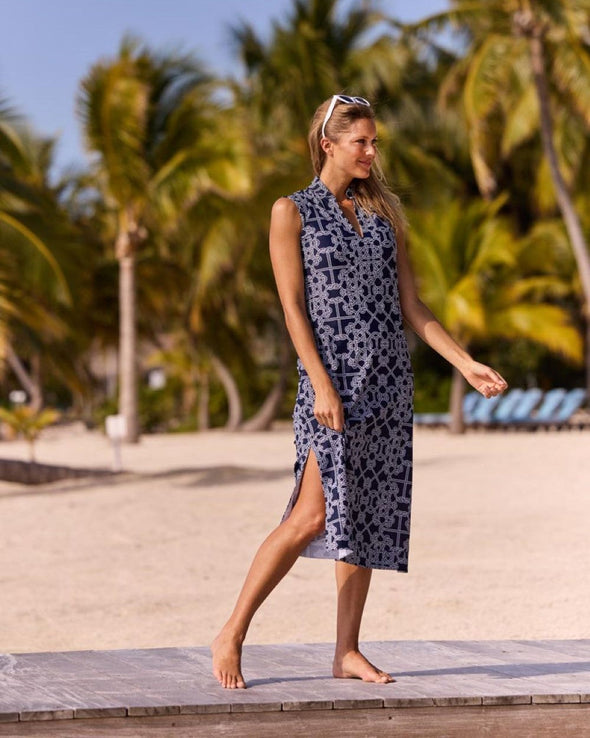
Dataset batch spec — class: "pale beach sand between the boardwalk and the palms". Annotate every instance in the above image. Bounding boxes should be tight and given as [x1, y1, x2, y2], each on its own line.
[0, 427, 590, 652]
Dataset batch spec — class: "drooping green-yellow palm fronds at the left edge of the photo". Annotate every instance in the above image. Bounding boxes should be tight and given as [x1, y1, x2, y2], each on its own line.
[0, 94, 79, 410]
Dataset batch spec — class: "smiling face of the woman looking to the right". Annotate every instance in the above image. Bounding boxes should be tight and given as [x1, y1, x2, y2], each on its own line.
[326, 118, 377, 179]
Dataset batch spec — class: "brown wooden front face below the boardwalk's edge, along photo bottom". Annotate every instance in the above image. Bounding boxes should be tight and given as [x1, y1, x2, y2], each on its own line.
[0, 704, 590, 738]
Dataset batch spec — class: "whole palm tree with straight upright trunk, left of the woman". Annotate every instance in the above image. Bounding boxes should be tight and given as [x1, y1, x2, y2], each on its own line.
[78, 38, 249, 442]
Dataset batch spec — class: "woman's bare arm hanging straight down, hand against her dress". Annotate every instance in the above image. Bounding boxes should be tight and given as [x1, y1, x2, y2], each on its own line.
[270, 197, 344, 431]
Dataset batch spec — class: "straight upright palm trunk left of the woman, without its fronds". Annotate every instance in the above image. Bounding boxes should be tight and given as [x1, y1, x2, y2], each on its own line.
[119, 253, 139, 443]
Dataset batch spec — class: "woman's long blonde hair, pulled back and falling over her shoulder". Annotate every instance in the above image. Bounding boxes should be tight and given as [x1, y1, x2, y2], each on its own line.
[307, 98, 407, 236]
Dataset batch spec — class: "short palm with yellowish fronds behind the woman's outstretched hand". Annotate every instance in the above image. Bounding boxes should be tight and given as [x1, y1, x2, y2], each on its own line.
[410, 198, 582, 433]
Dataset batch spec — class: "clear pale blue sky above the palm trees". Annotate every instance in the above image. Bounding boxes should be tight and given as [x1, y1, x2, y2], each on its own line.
[0, 0, 449, 170]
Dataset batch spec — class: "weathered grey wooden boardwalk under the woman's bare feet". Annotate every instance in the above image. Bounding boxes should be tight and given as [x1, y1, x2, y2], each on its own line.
[0, 640, 590, 738]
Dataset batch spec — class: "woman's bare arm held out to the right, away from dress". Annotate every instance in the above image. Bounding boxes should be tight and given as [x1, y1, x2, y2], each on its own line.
[397, 238, 508, 397]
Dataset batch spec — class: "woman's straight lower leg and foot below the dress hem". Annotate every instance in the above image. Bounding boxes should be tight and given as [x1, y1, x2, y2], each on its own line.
[332, 561, 395, 684]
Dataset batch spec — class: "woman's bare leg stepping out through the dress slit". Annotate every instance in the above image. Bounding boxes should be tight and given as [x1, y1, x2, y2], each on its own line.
[211, 451, 326, 689]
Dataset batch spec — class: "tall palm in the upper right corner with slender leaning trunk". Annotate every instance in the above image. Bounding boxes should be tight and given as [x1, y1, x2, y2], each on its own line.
[404, 0, 590, 389]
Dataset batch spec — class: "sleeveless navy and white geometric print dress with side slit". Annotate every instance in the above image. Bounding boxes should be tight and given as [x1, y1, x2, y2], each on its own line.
[283, 177, 413, 572]
